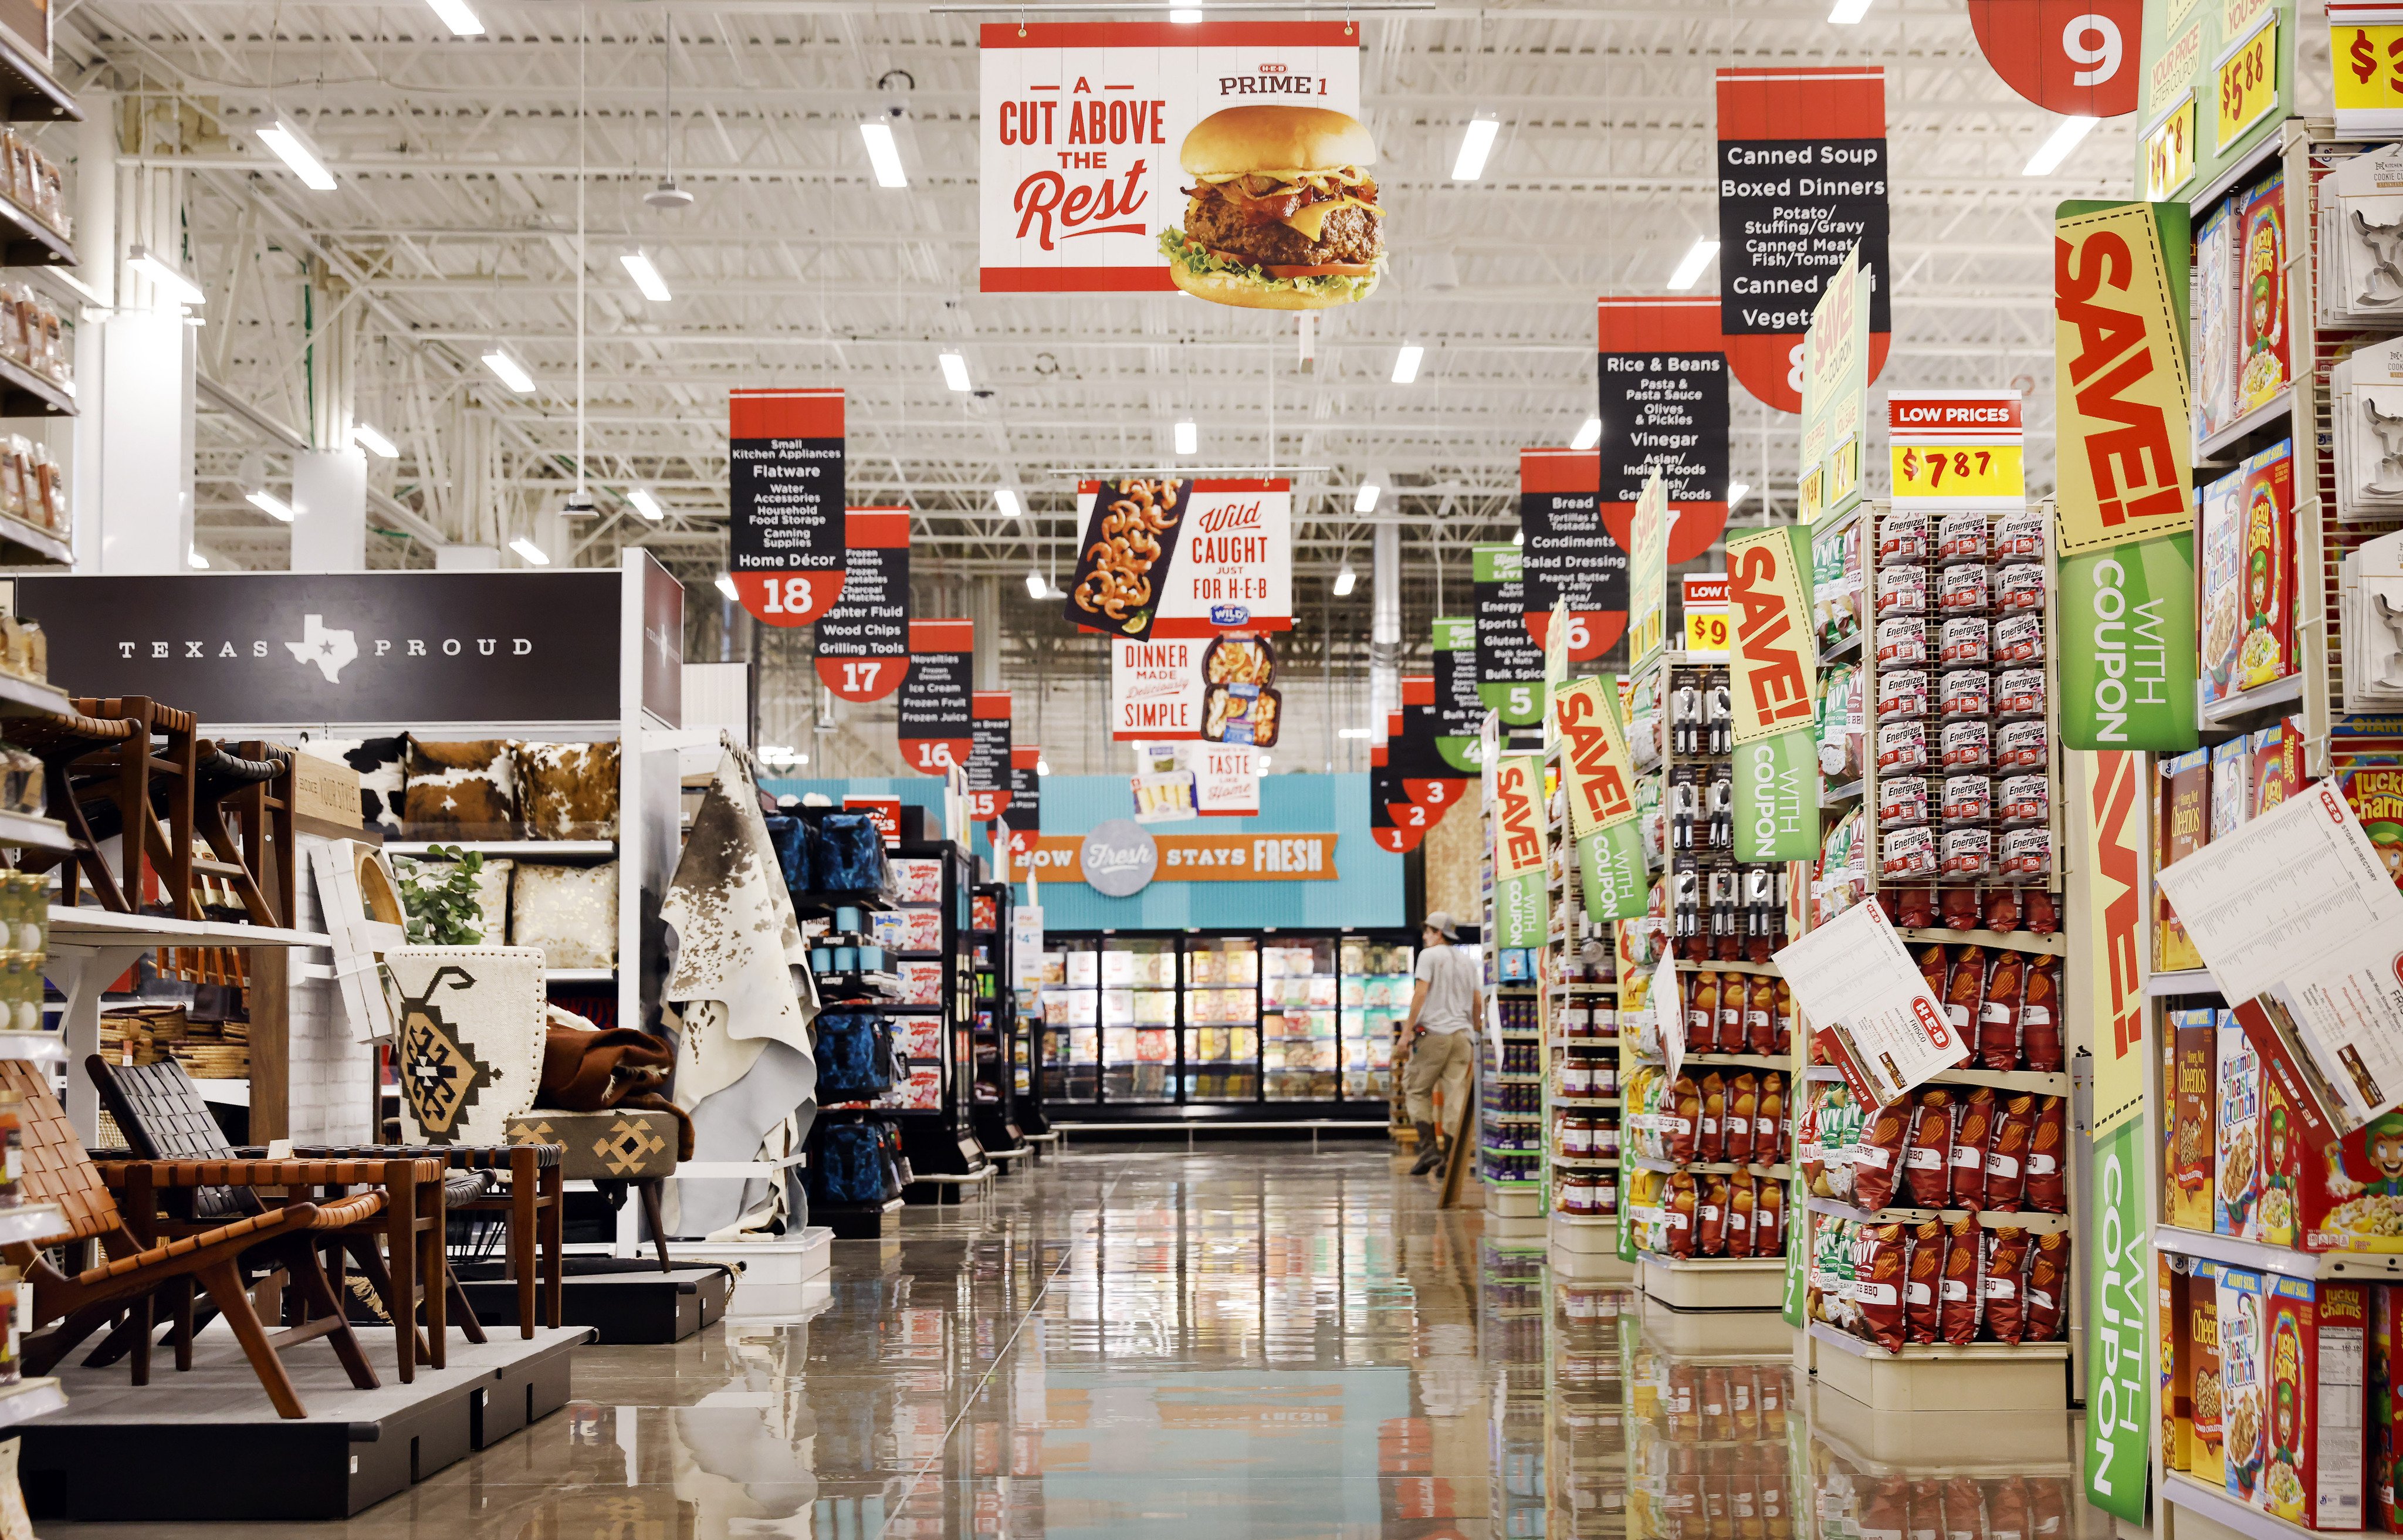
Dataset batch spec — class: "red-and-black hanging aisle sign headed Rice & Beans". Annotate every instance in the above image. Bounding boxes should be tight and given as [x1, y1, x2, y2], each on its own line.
[1596, 300, 1728, 564]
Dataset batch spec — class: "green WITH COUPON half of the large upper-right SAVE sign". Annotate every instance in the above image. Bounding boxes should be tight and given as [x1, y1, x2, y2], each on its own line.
[2066, 533, 2201, 754]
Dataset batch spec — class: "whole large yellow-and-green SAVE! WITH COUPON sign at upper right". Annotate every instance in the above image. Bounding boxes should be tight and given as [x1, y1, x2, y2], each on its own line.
[2052, 202, 2199, 752]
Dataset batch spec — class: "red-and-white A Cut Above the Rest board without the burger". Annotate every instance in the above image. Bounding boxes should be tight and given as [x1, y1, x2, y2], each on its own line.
[978, 22, 1360, 293]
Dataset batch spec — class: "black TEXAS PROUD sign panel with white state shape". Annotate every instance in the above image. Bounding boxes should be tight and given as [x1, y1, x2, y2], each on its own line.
[17, 572, 625, 728]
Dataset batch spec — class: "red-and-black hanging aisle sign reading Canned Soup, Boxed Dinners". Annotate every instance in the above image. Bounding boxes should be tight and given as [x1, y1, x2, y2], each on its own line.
[1718, 65, 1894, 413]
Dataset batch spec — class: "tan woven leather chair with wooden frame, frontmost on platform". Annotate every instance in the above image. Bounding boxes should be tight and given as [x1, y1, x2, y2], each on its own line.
[0, 1060, 418, 1417]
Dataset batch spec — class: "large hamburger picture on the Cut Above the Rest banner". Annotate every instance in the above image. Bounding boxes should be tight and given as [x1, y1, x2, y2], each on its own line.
[1160, 106, 1384, 310]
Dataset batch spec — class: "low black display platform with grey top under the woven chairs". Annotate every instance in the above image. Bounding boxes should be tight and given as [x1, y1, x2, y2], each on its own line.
[17, 1326, 594, 1523]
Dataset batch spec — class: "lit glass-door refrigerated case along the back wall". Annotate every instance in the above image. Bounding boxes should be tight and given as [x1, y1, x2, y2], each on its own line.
[1041, 930, 1416, 1119]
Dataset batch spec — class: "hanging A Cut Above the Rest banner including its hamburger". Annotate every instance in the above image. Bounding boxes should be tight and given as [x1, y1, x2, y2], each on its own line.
[978, 22, 1384, 310]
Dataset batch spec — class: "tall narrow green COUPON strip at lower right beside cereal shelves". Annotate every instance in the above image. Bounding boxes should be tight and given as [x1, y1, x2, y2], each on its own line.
[2083, 1117, 2155, 1523]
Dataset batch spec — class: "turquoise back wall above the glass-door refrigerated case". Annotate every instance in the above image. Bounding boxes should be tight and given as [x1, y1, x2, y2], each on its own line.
[764, 776, 1413, 930]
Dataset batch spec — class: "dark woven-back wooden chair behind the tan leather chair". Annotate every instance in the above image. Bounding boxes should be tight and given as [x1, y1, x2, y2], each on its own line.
[84, 1055, 485, 1384]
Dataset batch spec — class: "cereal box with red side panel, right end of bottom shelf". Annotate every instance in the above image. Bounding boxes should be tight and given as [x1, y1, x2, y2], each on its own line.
[2254, 1278, 2370, 1531]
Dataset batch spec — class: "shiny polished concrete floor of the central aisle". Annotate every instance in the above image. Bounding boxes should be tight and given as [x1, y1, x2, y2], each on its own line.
[41, 1139, 2107, 1540]
